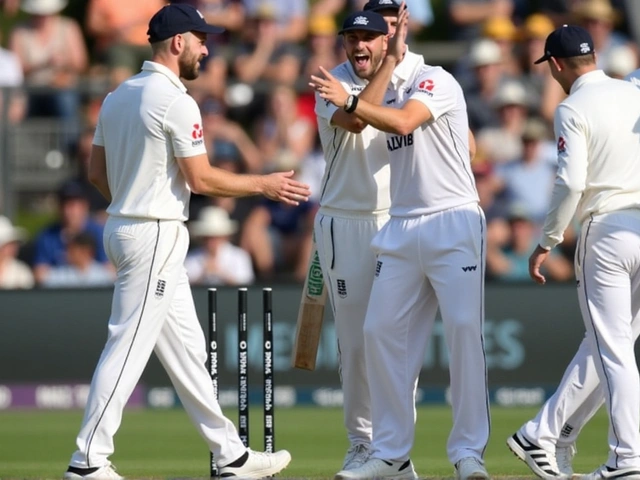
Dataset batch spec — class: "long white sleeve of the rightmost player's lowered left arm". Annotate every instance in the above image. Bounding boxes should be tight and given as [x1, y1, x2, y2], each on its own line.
[540, 104, 589, 249]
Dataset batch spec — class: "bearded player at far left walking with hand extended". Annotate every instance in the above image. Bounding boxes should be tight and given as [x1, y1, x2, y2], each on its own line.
[64, 4, 309, 479]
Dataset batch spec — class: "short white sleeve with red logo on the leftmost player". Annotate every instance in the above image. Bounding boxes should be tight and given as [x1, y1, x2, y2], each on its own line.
[164, 94, 207, 157]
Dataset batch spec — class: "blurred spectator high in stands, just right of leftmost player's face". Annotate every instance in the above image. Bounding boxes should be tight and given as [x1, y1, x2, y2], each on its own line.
[233, 2, 306, 85]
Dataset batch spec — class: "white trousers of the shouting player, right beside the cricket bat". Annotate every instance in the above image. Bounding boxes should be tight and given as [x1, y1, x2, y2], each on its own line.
[314, 209, 389, 445]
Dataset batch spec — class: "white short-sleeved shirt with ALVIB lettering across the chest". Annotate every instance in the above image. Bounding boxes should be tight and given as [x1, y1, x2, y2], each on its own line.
[387, 63, 478, 217]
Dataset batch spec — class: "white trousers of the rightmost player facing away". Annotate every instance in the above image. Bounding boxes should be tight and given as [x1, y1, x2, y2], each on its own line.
[521, 210, 640, 468]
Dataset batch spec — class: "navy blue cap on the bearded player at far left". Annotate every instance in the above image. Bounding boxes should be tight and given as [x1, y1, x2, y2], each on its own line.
[147, 3, 224, 43]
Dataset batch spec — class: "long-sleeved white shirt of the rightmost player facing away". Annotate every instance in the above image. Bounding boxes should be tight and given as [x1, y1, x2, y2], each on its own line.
[540, 70, 640, 248]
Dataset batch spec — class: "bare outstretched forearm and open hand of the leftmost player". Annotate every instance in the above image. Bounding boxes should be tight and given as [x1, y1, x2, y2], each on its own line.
[177, 154, 311, 205]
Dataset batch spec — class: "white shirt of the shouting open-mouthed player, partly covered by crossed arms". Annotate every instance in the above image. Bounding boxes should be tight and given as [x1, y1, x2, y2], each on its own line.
[315, 51, 423, 212]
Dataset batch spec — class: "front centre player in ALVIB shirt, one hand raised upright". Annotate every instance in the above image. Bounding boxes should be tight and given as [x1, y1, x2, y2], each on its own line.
[311, 7, 490, 480]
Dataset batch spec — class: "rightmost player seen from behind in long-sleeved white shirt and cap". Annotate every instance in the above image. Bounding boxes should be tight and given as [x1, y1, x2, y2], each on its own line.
[507, 25, 640, 480]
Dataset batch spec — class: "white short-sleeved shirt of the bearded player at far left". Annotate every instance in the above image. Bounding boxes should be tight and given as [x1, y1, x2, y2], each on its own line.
[93, 62, 206, 221]
